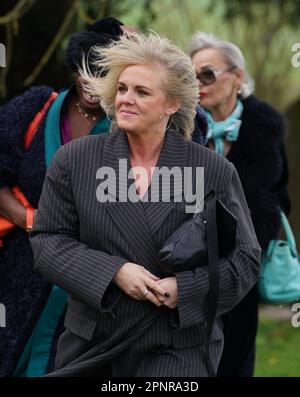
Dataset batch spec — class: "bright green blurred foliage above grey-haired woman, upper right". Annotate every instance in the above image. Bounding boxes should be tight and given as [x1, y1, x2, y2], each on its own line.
[152, 0, 300, 110]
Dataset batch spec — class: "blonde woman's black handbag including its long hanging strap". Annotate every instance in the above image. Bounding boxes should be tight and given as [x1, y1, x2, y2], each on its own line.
[158, 191, 237, 377]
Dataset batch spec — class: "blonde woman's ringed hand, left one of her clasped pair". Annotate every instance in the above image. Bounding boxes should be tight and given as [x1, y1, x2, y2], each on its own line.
[113, 262, 166, 306]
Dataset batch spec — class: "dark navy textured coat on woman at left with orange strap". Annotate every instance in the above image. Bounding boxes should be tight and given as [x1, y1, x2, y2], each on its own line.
[0, 86, 53, 377]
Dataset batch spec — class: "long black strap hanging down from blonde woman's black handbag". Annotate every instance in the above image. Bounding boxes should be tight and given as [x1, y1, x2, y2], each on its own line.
[204, 192, 219, 377]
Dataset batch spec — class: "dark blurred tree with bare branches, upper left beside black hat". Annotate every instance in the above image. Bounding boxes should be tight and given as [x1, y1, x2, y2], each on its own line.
[0, 0, 157, 101]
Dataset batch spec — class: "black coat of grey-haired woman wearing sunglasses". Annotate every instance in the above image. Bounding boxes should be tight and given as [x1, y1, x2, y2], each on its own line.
[193, 95, 290, 249]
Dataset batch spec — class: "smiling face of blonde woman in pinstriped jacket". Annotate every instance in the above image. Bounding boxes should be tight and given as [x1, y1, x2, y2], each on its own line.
[115, 65, 179, 134]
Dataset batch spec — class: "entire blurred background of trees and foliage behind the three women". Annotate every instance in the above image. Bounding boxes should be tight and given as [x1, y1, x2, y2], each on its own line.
[0, 0, 300, 246]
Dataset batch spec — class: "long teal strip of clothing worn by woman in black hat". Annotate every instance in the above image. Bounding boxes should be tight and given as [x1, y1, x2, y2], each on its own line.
[14, 91, 110, 377]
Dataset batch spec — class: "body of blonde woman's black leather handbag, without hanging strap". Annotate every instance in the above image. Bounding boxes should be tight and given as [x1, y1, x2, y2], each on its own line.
[158, 191, 237, 274]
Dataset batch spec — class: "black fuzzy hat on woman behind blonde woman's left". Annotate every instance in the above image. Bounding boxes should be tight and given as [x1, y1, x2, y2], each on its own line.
[65, 17, 123, 73]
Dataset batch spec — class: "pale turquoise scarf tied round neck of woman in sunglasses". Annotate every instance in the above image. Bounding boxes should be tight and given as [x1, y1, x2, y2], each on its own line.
[205, 99, 244, 156]
